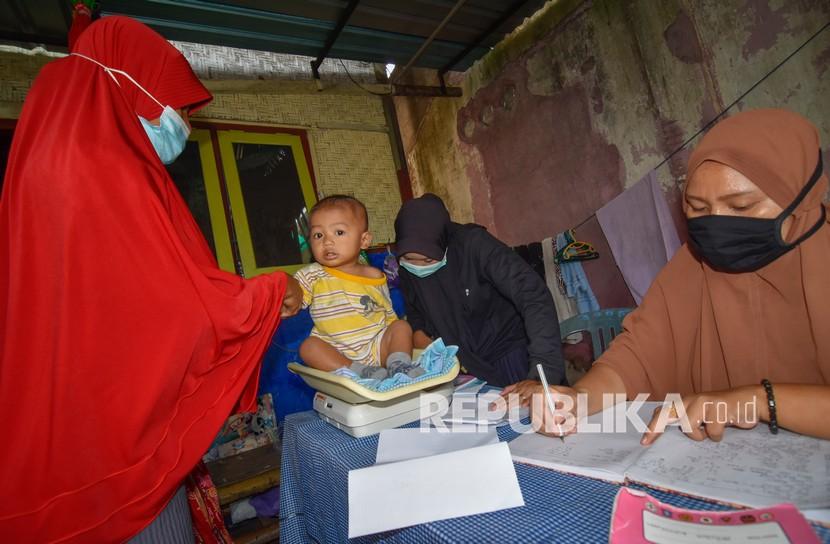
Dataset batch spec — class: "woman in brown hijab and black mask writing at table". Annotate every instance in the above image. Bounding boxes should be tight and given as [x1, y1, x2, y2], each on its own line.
[504, 109, 830, 444]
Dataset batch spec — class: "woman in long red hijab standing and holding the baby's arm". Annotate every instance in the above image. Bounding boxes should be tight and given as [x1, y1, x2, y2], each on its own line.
[0, 17, 299, 542]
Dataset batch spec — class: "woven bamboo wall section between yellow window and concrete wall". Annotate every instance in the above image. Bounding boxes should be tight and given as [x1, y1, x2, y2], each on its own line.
[311, 130, 401, 243]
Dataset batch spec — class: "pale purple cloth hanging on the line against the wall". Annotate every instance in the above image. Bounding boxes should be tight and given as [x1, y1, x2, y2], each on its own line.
[597, 171, 680, 305]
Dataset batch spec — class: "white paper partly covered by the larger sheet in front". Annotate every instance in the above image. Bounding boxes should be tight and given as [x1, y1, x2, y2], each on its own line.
[375, 425, 499, 464]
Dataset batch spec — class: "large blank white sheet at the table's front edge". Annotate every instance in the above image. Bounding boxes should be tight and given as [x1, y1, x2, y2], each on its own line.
[349, 442, 524, 538]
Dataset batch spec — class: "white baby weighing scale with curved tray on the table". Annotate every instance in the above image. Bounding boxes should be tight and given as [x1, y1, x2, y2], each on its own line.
[288, 359, 460, 438]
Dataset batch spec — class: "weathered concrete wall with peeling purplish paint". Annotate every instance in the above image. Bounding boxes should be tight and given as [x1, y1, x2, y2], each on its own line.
[396, 0, 830, 306]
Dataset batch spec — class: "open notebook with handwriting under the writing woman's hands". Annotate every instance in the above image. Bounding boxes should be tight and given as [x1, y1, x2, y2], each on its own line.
[510, 403, 830, 509]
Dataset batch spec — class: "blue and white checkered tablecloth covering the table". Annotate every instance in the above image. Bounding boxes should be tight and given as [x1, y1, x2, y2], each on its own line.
[280, 411, 830, 544]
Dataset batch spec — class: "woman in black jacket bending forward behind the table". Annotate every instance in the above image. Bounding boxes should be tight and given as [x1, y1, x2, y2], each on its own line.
[395, 194, 565, 386]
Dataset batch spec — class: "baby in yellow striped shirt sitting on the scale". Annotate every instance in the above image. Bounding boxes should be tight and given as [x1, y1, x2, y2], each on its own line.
[294, 195, 424, 380]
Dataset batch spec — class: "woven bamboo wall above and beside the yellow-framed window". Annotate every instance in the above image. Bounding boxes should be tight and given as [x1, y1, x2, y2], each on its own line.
[0, 43, 401, 243]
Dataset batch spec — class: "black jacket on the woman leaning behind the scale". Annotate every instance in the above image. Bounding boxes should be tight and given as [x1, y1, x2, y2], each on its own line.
[396, 222, 565, 386]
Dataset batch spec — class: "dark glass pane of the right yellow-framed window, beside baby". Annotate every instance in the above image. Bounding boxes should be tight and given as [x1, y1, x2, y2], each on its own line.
[233, 143, 311, 268]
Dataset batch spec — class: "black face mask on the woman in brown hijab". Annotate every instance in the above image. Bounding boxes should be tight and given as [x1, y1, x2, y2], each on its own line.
[688, 152, 826, 272]
